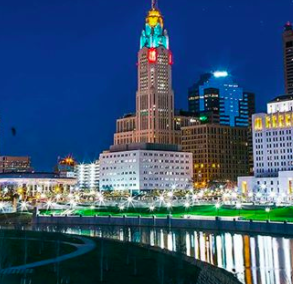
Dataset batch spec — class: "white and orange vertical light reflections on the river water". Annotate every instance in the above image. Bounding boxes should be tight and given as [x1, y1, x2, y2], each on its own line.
[38, 227, 293, 284]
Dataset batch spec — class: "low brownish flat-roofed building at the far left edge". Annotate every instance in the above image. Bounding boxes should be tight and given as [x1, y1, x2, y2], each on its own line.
[0, 156, 33, 173]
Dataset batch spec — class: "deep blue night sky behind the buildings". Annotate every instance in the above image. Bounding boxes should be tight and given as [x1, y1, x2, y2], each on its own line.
[0, 0, 293, 170]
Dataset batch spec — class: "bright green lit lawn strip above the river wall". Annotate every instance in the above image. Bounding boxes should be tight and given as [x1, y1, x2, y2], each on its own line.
[41, 205, 293, 222]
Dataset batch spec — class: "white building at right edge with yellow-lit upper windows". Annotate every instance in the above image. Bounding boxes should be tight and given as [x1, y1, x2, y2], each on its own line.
[238, 96, 293, 202]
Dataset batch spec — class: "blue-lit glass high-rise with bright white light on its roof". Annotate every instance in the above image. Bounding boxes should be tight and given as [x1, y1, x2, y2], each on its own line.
[188, 71, 254, 127]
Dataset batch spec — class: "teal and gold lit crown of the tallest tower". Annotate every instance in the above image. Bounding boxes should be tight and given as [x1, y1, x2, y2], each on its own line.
[140, 0, 169, 49]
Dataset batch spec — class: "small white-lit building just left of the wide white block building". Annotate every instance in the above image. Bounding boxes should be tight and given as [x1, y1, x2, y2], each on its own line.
[76, 160, 100, 190]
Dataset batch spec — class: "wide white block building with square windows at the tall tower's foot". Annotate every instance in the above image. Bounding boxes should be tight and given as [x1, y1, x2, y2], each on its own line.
[100, 143, 193, 192]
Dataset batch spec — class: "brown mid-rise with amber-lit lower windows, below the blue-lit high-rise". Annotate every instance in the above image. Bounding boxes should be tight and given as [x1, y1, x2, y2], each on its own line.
[182, 124, 249, 188]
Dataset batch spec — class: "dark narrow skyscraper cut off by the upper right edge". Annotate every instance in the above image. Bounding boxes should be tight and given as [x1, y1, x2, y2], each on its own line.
[283, 22, 293, 95]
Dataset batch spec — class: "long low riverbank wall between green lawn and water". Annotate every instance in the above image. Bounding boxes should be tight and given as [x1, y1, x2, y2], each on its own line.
[33, 215, 293, 236]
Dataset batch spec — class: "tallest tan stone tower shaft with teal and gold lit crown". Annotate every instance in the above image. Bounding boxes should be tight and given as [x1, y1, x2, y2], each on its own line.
[135, 0, 174, 144]
